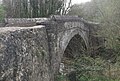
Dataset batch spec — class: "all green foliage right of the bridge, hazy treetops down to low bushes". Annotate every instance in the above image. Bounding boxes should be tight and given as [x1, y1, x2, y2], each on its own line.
[62, 0, 120, 81]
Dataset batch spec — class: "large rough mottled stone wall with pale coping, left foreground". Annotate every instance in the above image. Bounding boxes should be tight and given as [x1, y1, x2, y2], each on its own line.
[0, 26, 50, 81]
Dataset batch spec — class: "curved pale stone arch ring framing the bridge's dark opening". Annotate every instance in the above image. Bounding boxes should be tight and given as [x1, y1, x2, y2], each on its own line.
[55, 29, 88, 72]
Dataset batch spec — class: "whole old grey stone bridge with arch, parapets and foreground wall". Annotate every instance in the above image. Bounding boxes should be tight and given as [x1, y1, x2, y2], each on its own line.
[0, 16, 98, 81]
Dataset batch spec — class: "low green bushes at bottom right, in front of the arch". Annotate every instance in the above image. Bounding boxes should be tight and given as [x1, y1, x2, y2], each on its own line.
[74, 56, 120, 81]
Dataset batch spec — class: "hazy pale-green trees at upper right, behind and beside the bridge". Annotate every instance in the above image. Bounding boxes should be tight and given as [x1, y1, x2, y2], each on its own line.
[68, 0, 120, 58]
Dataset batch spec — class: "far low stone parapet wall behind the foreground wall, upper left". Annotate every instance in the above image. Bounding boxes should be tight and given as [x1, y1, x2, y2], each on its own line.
[5, 18, 48, 27]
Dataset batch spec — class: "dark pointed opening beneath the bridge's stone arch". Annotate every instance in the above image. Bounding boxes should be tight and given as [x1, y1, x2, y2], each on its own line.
[63, 34, 87, 59]
